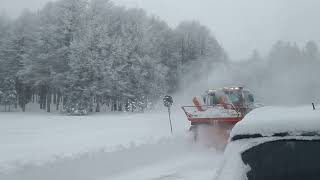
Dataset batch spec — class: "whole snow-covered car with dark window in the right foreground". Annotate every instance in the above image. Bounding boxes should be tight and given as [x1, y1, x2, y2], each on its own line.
[215, 107, 320, 180]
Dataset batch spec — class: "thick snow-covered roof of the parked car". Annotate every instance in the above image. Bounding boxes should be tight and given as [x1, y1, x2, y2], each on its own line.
[230, 105, 320, 141]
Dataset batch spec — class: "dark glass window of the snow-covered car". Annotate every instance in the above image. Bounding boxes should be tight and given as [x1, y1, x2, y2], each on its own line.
[242, 140, 320, 180]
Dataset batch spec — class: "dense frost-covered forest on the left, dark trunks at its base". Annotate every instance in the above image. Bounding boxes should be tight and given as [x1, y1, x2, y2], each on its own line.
[0, 0, 227, 115]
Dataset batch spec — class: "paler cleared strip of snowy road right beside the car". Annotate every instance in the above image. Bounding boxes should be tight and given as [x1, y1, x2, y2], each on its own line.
[111, 150, 221, 180]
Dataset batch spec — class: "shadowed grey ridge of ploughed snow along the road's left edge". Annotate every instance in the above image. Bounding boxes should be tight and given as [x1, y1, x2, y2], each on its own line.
[0, 138, 220, 180]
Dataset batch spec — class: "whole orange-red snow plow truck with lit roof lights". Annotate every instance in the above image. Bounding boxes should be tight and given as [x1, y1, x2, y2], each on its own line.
[182, 86, 255, 145]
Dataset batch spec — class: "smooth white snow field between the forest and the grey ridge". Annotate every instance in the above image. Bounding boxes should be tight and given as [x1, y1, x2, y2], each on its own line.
[0, 112, 189, 173]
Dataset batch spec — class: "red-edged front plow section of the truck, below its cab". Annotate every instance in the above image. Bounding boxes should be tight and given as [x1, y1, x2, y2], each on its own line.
[181, 104, 243, 150]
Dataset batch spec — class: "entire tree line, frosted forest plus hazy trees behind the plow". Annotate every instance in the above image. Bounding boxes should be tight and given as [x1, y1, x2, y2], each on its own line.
[0, 0, 320, 115]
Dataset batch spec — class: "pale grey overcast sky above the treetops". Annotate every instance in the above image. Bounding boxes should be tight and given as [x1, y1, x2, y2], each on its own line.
[0, 0, 320, 59]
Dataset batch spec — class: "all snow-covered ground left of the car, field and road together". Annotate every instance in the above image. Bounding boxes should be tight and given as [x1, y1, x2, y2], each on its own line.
[0, 111, 221, 180]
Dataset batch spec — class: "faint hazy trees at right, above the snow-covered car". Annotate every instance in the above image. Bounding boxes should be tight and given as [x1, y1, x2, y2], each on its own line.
[229, 40, 320, 105]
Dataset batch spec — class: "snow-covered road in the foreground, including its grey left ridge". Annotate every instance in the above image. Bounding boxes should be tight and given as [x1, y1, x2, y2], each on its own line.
[0, 142, 221, 180]
